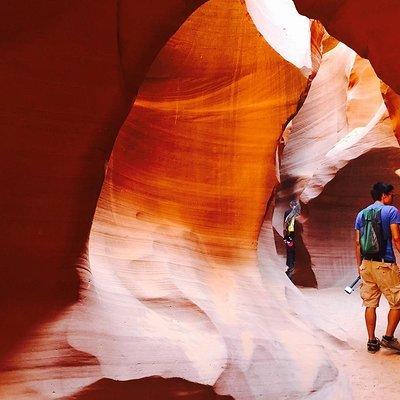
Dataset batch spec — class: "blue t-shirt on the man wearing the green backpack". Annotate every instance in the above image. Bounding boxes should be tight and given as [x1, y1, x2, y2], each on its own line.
[355, 203, 400, 262]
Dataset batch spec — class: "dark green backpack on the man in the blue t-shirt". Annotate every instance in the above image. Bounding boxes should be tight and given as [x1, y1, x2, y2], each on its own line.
[360, 208, 386, 259]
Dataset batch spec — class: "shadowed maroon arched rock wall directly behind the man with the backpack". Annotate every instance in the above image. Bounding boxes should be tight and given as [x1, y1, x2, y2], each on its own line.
[303, 147, 400, 288]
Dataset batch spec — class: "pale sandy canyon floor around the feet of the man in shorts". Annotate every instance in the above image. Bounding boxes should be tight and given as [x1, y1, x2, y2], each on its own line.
[301, 287, 400, 400]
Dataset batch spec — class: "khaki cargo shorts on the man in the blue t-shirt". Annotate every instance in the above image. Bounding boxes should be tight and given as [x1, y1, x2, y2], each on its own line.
[360, 260, 400, 309]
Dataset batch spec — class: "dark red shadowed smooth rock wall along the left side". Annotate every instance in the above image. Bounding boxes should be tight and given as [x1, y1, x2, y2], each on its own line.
[0, 0, 206, 355]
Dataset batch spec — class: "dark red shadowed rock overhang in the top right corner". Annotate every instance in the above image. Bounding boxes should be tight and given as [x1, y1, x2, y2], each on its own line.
[293, 0, 400, 93]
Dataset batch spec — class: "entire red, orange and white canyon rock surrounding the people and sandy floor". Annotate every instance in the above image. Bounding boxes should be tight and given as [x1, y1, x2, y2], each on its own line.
[0, 0, 400, 400]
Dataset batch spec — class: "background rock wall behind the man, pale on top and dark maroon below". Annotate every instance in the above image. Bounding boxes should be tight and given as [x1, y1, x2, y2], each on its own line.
[273, 44, 399, 288]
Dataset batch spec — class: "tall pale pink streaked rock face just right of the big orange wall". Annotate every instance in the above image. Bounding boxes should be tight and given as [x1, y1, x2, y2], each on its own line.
[277, 44, 354, 208]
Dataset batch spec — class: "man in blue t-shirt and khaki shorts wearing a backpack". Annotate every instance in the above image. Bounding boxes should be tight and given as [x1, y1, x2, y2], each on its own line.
[355, 182, 400, 353]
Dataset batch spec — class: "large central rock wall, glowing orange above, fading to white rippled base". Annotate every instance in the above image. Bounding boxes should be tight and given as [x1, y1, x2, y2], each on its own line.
[81, 1, 347, 399]
